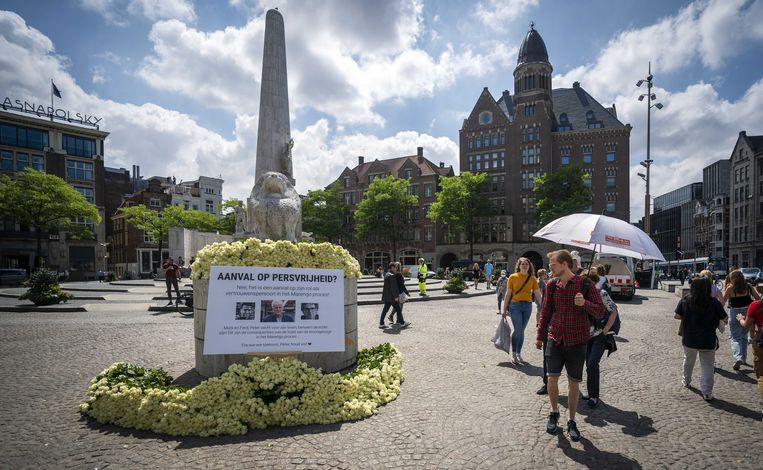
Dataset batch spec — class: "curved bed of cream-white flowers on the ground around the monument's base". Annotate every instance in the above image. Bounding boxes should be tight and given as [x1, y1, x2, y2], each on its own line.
[80, 343, 403, 436]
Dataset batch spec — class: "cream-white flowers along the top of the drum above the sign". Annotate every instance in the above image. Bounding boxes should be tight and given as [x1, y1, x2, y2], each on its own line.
[191, 238, 361, 279]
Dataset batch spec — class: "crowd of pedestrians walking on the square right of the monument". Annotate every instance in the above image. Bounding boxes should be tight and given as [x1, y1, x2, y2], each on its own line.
[379, 250, 763, 441]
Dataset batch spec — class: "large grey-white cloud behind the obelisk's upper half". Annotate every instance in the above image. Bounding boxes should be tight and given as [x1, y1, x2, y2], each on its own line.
[139, 0, 516, 125]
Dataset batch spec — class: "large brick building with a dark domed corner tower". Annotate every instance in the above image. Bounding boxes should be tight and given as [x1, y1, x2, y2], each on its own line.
[454, 26, 631, 265]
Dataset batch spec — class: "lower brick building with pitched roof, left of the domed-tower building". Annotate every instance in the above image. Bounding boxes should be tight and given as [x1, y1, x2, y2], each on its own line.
[332, 147, 454, 271]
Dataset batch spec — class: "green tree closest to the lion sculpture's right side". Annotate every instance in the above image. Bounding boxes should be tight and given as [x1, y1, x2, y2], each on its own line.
[302, 183, 349, 243]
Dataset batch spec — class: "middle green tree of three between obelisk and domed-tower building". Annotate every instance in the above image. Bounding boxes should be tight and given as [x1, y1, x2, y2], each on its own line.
[355, 176, 419, 259]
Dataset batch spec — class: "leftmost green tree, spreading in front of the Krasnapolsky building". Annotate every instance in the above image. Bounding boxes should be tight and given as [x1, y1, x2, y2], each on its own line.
[0, 168, 101, 268]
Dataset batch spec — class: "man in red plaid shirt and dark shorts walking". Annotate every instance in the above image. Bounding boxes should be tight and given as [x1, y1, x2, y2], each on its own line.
[535, 250, 605, 441]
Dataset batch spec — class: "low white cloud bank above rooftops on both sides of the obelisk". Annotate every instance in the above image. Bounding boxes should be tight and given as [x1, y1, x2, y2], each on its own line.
[0, 12, 458, 205]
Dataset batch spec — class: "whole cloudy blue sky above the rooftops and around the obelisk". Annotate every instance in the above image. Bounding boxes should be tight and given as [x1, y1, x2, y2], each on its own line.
[0, 0, 763, 220]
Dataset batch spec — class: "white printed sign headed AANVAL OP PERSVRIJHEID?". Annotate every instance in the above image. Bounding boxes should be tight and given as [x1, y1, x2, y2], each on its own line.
[204, 266, 344, 354]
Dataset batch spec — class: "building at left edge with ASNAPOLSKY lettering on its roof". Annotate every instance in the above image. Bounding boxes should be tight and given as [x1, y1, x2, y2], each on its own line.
[0, 110, 109, 280]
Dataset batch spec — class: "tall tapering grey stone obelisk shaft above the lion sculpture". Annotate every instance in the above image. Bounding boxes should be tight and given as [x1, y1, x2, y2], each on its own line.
[254, 10, 294, 185]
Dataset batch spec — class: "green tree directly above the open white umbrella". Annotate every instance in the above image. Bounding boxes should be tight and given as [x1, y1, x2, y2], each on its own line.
[533, 165, 593, 227]
